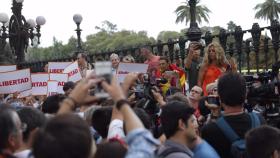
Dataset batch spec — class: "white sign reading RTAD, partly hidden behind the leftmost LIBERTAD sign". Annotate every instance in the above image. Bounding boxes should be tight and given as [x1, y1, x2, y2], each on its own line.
[31, 73, 49, 95]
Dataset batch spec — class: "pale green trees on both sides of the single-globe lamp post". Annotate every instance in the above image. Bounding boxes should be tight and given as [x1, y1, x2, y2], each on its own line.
[26, 21, 156, 61]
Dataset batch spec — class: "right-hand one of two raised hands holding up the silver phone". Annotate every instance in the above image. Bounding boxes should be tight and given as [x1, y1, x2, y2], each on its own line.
[101, 76, 126, 102]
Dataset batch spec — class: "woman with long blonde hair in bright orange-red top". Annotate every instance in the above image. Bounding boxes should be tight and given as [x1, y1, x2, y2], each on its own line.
[197, 42, 231, 95]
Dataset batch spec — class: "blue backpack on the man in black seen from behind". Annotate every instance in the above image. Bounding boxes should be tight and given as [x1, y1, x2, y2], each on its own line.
[216, 113, 261, 158]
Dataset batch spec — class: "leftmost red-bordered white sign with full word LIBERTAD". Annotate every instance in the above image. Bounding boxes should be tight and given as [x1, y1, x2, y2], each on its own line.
[0, 69, 31, 94]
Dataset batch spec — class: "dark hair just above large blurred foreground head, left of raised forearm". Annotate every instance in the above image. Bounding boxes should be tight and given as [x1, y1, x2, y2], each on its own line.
[42, 94, 65, 114]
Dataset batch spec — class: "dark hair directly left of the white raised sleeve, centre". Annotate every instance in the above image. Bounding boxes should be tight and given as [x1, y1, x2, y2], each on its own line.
[91, 107, 112, 138]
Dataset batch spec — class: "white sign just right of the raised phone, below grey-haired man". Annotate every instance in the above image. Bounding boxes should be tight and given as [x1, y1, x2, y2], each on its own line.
[117, 63, 149, 83]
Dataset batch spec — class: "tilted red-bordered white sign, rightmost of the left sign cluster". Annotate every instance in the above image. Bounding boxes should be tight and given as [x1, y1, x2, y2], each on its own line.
[63, 61, 82, 82]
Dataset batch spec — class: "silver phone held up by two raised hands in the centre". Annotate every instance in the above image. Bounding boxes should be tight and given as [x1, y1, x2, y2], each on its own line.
[94, 61, 112, 98]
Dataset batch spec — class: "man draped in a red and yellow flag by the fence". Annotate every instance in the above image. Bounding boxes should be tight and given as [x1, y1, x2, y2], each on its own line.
[156, 56, 186, 95]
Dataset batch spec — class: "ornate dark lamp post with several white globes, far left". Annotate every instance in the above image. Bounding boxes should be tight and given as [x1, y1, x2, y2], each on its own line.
[0, 0, 46, 64]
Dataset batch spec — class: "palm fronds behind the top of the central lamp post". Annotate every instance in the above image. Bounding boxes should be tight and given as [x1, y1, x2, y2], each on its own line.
[175, 0, 211, 25]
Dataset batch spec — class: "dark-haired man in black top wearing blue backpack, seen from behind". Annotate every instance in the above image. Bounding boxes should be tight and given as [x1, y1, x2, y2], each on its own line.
[201, 72, 265, 158]
